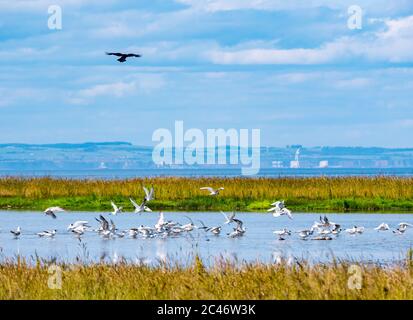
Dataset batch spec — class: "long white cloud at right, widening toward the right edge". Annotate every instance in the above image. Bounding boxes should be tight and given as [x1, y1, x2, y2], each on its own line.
[206, 16, 413, 65]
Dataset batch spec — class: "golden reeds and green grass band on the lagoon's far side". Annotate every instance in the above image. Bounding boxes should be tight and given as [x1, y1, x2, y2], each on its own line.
[0, 177, 413, 212]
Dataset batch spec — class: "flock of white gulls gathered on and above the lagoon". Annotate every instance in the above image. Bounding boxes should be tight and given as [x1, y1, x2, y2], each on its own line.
[5, 187, 413, 240]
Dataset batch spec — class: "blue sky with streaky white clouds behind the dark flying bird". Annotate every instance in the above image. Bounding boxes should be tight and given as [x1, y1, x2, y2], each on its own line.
[0, 0, 413, 147]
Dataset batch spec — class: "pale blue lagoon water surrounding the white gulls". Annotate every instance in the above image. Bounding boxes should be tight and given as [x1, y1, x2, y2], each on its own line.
[0, 211, 413, 265]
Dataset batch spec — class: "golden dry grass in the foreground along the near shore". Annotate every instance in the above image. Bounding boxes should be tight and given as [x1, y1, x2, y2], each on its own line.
[0, 260, 413, 300]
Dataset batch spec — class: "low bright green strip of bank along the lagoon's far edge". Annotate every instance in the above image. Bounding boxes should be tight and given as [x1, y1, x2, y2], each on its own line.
[0, 197, 413, 214]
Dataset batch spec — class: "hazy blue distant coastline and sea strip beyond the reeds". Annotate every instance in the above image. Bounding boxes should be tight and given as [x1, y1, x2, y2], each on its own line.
[0, 142, 413, 172]
